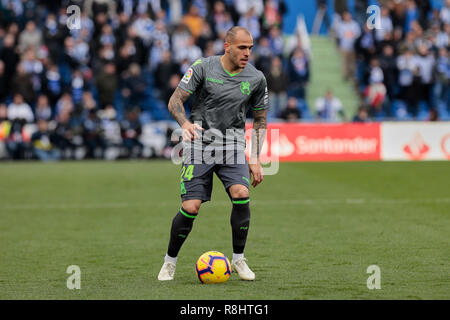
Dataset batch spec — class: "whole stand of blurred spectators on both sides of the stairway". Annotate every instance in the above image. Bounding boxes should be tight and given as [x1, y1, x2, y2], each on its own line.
[0, 0, 450, 160]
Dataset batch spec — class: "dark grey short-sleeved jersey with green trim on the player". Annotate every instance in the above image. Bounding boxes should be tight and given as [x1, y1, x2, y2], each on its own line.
[178, 56, 268, 145]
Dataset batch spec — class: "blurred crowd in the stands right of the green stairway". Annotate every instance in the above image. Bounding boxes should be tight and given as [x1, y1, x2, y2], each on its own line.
[331, 0, 450, 121]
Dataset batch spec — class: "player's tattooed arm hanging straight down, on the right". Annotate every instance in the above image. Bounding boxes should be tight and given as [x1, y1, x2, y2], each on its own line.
[249, 110, 267, 187]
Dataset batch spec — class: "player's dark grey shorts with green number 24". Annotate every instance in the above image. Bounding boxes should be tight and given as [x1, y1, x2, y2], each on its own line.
[180, 146, 250, 202]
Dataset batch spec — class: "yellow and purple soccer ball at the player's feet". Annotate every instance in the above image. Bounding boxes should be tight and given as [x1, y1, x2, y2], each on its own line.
[195, 251, 231, 284]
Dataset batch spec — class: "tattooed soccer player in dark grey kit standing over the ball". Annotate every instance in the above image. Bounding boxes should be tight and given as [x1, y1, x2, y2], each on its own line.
[158, 27, 268, 280]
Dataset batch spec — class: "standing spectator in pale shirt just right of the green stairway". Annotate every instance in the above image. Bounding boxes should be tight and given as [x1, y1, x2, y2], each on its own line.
[337, 12, 361, 80]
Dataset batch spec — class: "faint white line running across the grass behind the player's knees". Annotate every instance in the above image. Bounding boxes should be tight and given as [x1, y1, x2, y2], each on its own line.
[0, 198, 450, 212]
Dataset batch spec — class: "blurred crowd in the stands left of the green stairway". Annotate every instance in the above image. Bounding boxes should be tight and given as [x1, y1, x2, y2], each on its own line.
[0, 0, 309, 160]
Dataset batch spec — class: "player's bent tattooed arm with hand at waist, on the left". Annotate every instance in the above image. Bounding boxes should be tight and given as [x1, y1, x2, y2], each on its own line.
[168, 87, 203, 141]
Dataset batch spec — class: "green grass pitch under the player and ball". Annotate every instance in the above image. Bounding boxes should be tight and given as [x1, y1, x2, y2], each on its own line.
[0, 161, 450, 300]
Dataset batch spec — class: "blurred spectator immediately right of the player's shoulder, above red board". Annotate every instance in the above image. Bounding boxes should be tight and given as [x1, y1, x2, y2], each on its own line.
[266, 56, 289, 118]
